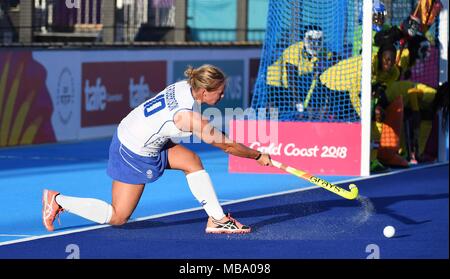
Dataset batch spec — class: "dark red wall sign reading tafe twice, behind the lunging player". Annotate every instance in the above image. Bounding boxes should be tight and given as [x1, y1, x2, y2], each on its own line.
[81, 61, 167, 127]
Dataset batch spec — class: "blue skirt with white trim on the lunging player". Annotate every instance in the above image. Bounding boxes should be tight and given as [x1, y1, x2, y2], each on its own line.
[106, 132, 168, 184]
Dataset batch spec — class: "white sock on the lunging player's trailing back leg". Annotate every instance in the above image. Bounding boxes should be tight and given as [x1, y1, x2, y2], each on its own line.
[56, 194, 112, 224]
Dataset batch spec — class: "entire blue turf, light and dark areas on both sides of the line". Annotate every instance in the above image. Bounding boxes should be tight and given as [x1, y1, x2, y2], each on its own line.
[0, 140, 448, 259]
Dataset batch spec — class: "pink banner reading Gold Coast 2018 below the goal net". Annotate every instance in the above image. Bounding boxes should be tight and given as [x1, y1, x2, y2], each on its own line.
[229, 120, 361, 175]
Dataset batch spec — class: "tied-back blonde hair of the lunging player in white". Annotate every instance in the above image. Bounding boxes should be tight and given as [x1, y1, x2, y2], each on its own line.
[184, 64, 226, 91]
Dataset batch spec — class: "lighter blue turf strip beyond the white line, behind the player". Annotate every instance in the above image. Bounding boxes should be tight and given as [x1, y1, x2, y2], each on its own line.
[0, 139, 349, 245]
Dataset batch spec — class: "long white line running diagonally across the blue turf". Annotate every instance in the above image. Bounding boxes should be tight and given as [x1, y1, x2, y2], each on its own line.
[0, 162, 449, 246]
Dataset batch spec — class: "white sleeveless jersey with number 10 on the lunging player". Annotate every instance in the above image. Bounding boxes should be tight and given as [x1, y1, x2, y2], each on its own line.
[117, 81, 195, 157]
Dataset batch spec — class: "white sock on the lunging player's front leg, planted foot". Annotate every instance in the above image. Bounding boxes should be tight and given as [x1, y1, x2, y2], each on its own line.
[186, 170, 225, 220]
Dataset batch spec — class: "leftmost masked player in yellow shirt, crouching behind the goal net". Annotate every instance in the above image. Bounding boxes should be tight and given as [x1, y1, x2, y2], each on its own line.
[267, 26, 338, 121]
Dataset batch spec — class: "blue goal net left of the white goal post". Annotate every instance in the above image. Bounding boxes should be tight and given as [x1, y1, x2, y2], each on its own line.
[252, 0, 368, 122]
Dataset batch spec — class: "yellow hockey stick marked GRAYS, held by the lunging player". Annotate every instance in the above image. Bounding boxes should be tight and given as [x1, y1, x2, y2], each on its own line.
[272, 159, 358, 200]
